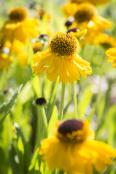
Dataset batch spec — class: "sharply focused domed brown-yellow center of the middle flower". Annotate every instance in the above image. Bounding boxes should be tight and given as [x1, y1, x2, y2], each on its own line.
[49, 33, 79, 56]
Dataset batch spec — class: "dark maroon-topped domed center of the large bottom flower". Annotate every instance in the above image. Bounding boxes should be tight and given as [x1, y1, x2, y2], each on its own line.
[57, 119, 89, 143]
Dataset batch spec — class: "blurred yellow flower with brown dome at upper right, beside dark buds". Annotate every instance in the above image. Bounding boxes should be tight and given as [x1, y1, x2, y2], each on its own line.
[67, 3, 112, 45]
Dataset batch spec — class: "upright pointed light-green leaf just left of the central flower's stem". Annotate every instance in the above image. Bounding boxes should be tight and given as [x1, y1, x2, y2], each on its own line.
[48, 106, 58, 136]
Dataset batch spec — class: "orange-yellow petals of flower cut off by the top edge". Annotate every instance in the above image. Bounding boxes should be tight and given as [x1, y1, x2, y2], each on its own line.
[71, 0, 110, 5]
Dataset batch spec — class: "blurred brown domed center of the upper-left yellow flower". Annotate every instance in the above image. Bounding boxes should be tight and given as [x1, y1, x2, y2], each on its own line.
[9, 7, 28, 21]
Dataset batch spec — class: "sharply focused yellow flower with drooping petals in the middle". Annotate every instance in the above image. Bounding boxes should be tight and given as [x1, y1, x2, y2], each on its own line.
[32, 33, 92, 83]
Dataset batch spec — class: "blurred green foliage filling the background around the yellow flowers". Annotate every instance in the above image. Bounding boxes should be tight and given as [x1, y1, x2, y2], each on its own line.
[0, 0, 116, 174]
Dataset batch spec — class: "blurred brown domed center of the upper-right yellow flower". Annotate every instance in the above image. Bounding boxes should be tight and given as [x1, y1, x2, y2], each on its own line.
[74, 3, 97, 23]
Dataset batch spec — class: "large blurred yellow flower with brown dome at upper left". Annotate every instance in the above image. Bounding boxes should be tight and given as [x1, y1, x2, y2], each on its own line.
[1, 7, 40, 42]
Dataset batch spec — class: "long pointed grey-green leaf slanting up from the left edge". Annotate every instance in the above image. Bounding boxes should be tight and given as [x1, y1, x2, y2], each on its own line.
[0, 85, 23, 123]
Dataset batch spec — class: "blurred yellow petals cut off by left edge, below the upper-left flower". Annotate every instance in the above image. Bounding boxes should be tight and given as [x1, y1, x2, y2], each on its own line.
[0, 53, 13, 72]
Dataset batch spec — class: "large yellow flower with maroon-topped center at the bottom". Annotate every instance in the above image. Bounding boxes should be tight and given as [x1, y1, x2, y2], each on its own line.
[39, 119, 116, 174]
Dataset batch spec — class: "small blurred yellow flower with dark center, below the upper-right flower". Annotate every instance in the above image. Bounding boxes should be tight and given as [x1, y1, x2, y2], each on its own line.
[95, 33, 116, 49]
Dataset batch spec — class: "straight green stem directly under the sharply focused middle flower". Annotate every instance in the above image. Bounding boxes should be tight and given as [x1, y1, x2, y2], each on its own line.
[59, 83, 65, 120]
